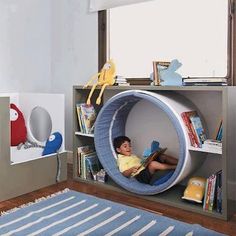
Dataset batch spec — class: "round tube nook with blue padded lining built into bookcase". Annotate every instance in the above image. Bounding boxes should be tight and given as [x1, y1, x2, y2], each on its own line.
[94, 90, 205, 195]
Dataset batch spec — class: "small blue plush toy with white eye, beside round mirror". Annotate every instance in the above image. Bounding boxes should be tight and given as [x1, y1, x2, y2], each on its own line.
[42, 132, 62, 156]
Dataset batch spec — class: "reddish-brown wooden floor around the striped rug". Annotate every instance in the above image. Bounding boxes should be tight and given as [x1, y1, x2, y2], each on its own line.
[0, 166, 236, 236]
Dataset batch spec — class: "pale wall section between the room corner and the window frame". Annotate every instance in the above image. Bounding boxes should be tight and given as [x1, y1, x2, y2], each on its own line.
[52, 0, 98, 150]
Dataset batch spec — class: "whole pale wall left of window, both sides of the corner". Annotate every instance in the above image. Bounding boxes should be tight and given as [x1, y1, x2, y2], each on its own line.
[0, 0, 98, 150]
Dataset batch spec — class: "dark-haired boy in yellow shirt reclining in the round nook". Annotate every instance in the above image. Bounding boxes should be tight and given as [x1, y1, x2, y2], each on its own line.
[113, 136, 178, 184]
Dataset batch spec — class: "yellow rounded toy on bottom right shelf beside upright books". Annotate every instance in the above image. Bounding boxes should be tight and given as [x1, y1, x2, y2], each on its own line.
[182, 177, 206, 203]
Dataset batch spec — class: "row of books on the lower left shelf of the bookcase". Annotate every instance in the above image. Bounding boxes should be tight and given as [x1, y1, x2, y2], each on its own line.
[77, 145, 107, 182]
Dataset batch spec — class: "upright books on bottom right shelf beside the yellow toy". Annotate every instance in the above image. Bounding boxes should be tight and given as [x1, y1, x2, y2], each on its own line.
[203, 170, 222, 213]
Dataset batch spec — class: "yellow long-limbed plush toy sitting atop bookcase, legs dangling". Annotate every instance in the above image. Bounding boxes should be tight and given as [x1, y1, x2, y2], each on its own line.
[84, 60, 116, 105]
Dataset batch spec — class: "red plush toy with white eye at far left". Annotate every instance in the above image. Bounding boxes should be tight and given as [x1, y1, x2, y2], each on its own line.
[10, 103, 27, 146]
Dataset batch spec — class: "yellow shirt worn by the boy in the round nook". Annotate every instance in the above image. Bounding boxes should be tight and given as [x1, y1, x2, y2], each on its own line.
[117, 154, 145, 176]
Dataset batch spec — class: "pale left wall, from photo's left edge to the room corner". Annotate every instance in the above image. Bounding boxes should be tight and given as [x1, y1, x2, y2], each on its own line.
[0, 0, 51, 92]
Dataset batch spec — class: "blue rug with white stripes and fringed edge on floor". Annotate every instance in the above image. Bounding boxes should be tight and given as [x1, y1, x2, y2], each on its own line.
[0, 189, 222, 236]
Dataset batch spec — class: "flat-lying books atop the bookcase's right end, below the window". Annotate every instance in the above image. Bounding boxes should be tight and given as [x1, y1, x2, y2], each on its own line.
[183, 78, 228, 86]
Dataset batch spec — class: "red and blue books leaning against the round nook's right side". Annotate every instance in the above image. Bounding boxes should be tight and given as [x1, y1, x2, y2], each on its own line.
[181, 111, 206, 148]
